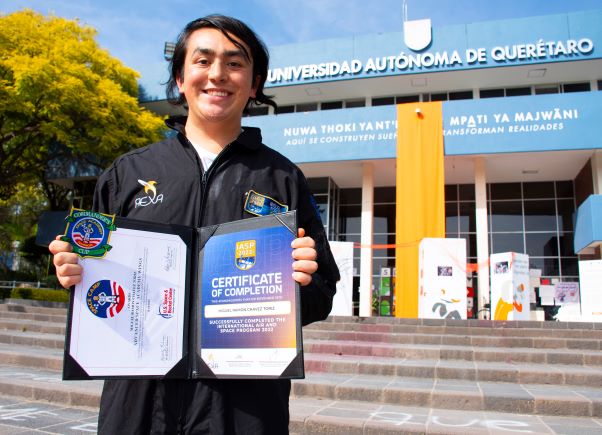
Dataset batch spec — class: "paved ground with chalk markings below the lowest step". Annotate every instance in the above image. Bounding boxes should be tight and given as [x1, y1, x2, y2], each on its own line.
[0, 397, 602, 435]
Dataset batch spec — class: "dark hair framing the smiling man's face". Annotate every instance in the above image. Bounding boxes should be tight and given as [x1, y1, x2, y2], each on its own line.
[167, 15, 276, 110]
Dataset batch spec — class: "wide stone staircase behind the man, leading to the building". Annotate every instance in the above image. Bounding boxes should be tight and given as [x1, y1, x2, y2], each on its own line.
[0, 304, 602, 435]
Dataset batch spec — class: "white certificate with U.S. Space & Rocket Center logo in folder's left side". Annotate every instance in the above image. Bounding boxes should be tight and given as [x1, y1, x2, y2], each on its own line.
[68, 227, 187, 377]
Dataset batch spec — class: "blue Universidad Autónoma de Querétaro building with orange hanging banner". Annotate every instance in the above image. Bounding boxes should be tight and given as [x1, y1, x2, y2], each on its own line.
[52, 6, 602, 317]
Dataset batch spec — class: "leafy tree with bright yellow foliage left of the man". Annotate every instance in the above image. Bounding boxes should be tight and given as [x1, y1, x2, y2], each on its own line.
[0, 10, 164, 199]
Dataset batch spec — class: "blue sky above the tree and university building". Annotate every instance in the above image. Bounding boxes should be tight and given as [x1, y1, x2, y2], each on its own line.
[0, 0, 602, 98]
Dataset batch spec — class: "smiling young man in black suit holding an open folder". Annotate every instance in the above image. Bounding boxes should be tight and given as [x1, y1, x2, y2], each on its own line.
[50, 15, 339, 434]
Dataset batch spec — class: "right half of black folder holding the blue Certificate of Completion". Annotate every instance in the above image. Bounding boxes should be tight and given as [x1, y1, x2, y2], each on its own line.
[191, 212, 304, 378]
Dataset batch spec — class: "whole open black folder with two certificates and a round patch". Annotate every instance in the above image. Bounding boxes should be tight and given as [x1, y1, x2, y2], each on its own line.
[63, 211, 303, 379]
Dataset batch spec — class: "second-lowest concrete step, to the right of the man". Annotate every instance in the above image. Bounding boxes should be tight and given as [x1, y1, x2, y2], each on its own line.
[304, 353, 602, 386]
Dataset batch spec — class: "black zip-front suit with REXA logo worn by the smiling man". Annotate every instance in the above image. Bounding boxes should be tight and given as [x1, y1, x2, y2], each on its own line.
[94, 118, 339, 434]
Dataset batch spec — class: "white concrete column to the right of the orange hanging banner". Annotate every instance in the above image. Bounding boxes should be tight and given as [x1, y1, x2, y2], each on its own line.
[474, 157, 490, 319]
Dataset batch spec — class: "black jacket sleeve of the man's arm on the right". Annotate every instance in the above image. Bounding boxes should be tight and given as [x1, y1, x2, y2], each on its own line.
[297, 174, 340, 326]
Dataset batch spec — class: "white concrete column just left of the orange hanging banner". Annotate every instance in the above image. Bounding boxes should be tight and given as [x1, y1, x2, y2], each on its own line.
[360, 163, 374, 317]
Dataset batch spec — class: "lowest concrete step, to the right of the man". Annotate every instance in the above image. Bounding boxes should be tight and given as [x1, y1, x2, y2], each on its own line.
[292, 373, 602, 417]
